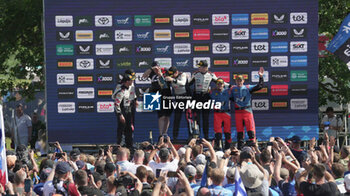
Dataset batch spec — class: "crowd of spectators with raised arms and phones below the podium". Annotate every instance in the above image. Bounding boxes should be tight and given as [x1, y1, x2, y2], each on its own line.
[0, 134, 350, 196]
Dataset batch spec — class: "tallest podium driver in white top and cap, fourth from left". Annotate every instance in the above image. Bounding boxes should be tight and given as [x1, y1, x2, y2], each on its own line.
[189, 61, 221, 140]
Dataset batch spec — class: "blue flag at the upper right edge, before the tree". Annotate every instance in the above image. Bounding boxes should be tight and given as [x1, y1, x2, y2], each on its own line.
[327, 14, 350, 66]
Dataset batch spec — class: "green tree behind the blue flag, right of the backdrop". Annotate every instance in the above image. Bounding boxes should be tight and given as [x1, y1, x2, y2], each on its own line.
[319, 0, 350, 105]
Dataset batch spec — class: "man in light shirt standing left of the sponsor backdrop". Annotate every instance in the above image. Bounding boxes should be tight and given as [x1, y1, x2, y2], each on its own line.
[12, 104, 32, 146]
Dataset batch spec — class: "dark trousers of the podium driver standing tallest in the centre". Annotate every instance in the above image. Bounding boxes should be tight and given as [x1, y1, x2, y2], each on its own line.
[193, 93, 210, 140]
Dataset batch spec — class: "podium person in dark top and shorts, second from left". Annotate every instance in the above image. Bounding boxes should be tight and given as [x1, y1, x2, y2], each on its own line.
[142, 61, 172, 135]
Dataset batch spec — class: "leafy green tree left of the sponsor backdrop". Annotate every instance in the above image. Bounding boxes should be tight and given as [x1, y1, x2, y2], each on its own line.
[0, 0, 45, 99]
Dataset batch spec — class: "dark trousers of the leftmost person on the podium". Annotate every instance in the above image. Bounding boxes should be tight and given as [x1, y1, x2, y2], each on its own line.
[117, 112, 134, 148]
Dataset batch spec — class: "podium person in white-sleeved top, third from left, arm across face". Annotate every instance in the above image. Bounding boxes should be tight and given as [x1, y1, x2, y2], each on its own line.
[165, 66, 192, 140]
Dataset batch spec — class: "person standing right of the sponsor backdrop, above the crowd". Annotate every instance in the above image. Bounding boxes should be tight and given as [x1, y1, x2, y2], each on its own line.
[320, 107, 343, 138]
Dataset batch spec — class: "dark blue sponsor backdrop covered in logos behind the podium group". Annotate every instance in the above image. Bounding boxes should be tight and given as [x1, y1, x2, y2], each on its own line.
[44, 0, 318, 143]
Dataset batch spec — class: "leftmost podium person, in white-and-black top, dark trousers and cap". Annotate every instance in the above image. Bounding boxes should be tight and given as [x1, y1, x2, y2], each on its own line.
[114, 74, 136, 148]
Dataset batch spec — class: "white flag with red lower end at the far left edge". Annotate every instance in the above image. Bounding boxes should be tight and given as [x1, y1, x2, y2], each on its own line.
[0, 105, 8, 187]
